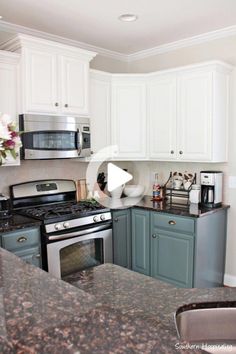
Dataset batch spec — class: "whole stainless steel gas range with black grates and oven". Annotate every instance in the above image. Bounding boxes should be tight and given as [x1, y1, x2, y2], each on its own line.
[10, 179, 113, 278]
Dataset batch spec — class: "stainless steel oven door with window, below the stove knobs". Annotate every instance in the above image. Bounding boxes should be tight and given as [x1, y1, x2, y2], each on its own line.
[46, 225, 113, 278]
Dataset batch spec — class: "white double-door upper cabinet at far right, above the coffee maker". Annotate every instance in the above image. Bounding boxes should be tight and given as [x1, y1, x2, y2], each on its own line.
[147, 62, 232, 162]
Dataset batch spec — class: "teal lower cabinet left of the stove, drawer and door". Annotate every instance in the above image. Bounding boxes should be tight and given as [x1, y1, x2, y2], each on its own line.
[0, 227, 42, 268]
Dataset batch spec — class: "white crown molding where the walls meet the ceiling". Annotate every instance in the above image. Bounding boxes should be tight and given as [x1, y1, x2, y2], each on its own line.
[0, 21, 236, 62]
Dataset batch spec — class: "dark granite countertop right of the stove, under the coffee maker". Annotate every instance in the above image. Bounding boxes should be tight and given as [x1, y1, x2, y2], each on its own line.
[110, 195, 230, 218]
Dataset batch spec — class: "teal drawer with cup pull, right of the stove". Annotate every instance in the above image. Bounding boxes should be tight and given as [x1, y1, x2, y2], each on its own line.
[152, 212, 194, 234]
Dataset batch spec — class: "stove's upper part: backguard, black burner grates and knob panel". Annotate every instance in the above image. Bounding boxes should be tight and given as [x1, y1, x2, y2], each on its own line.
[11, 180, 111, 233]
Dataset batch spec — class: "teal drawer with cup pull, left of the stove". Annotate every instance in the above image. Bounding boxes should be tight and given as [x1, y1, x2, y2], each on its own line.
[2, 228, 40, 251]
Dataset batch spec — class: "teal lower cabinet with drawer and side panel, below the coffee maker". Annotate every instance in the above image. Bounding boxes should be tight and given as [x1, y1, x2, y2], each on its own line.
[132, 208, 227, 288]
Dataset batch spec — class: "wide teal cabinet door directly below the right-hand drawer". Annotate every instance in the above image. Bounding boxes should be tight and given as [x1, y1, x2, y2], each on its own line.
[151, 228, 194, 288]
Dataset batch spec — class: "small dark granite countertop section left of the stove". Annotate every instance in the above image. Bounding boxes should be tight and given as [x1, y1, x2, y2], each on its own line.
[0, 213, 41, 233]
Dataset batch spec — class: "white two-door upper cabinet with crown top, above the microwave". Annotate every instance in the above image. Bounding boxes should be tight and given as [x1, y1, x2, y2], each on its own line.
[1, 34, 95, 116]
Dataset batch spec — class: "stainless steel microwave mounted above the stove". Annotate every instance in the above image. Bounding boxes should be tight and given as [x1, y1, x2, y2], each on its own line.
[19, 114, 91, 160]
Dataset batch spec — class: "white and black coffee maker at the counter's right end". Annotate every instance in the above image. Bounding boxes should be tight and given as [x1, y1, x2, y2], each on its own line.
[200, 171, 223, 208]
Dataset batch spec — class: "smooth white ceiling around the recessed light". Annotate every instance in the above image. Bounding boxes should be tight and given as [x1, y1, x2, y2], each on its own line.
[0, 0, 236, 54]
